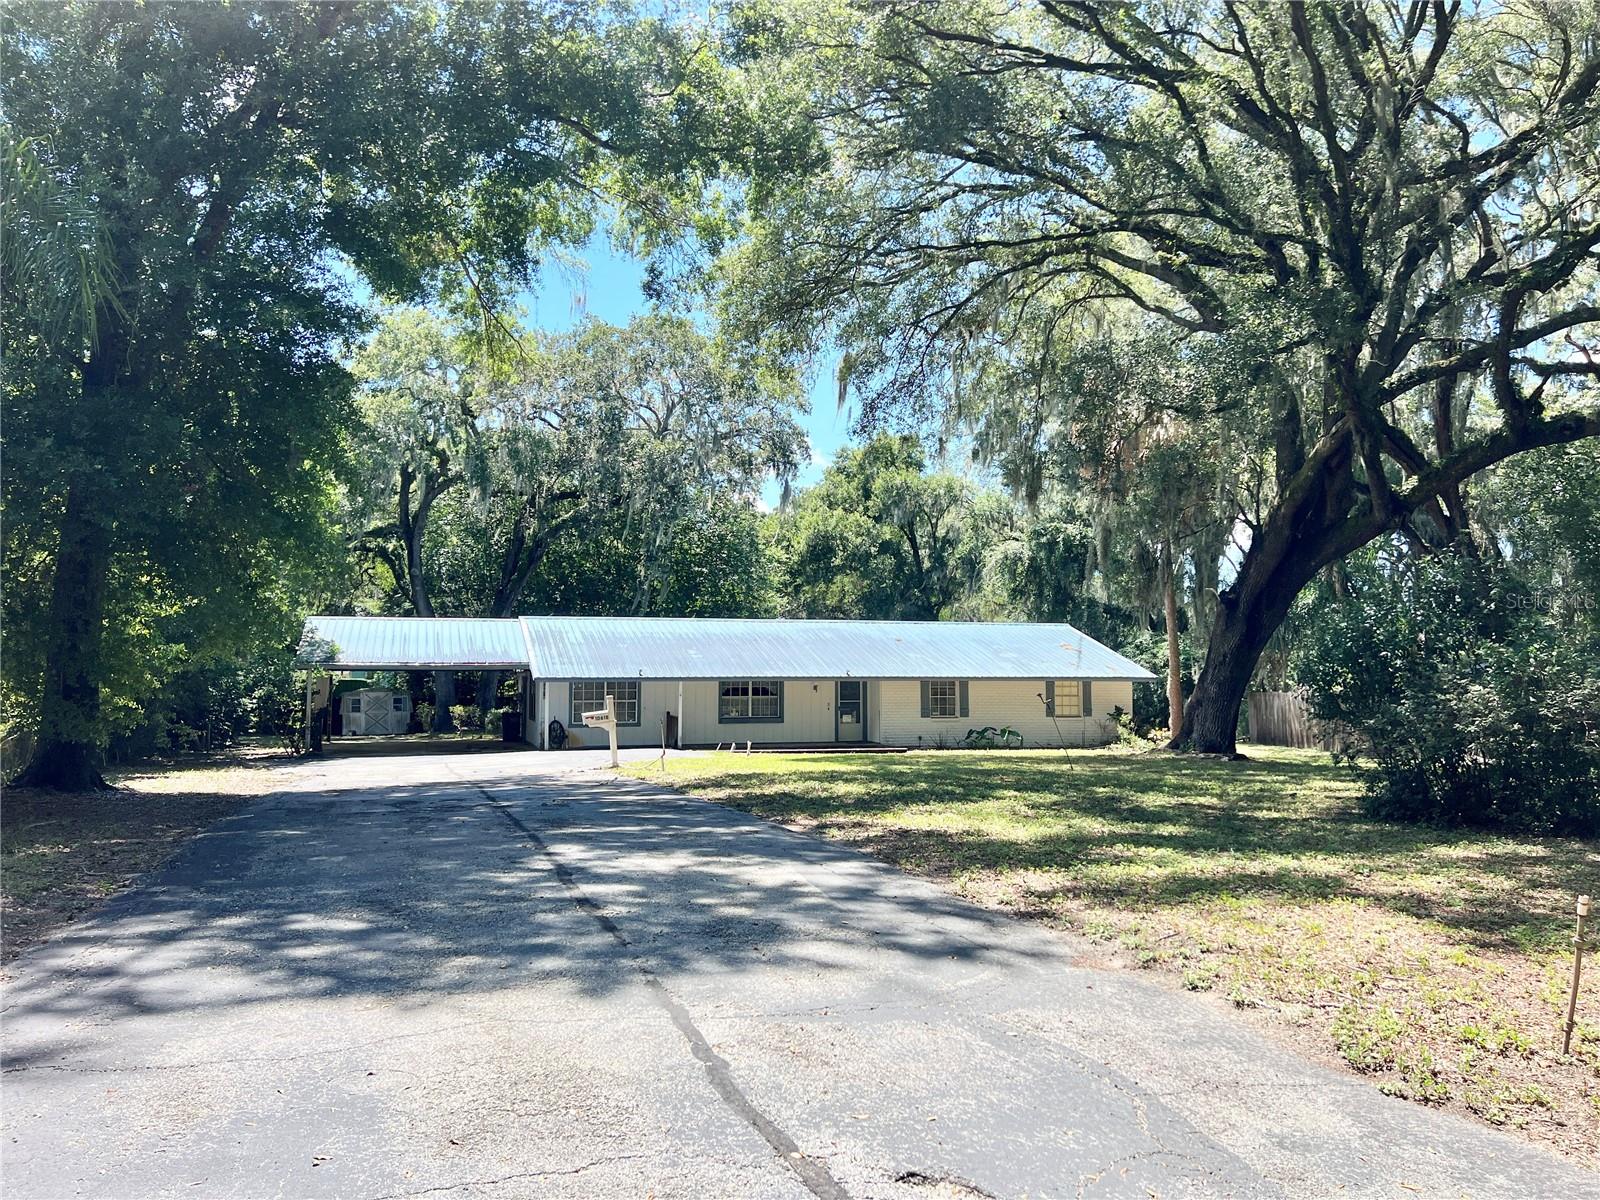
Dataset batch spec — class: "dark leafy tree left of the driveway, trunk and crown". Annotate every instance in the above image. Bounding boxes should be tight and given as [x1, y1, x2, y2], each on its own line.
[0, 2, 739, 787]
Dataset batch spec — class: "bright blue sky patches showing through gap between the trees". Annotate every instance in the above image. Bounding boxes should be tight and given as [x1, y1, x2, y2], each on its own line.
[518, 232, 853, 507]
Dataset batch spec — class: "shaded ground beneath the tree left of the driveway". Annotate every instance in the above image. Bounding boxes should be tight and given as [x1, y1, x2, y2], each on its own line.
[0, 747, 285, 962]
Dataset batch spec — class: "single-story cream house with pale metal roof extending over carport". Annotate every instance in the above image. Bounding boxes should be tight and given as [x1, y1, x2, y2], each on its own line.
[301, 616, 1155, 749]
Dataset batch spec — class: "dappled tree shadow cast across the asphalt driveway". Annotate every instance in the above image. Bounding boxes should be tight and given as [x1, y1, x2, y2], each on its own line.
[5, 774, 1066, 1070]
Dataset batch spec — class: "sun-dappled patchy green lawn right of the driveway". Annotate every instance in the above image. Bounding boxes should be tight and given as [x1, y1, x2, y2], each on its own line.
[626, 747, 1600, 1158]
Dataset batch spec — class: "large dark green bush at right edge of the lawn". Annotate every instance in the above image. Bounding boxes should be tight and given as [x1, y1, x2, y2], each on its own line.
[1299, 555, 1600, 835]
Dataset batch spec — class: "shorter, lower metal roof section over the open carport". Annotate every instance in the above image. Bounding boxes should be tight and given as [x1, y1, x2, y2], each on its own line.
[301, 616, 528, 670]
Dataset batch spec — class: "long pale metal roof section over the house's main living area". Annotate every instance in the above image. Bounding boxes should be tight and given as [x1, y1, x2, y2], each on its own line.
[522, 616, 1155, 682]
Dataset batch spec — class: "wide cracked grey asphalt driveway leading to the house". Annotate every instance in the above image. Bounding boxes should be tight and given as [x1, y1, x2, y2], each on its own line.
[0, 754, 1600, 1200]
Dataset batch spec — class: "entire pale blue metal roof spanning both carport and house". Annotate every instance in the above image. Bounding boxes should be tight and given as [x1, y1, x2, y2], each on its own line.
[301, 616, 1155, 682]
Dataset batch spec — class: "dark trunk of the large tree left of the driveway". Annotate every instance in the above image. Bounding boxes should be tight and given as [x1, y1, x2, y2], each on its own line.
[16, 485, 112, 792]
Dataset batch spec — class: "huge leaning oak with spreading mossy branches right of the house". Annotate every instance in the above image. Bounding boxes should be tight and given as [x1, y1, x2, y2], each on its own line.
[725, 0, 1600, 752]
